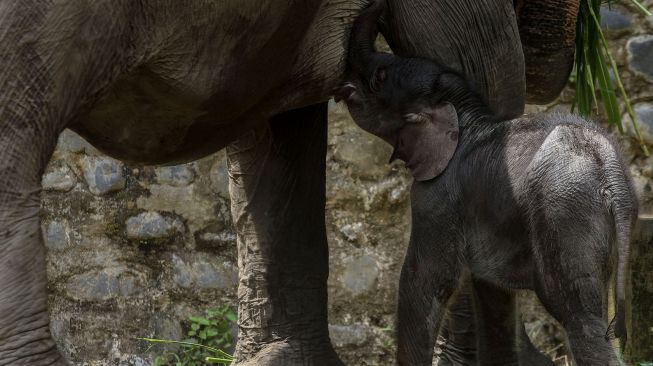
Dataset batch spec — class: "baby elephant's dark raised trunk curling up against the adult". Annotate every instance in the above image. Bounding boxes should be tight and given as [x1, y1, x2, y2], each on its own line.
[348, 0, 384, 77]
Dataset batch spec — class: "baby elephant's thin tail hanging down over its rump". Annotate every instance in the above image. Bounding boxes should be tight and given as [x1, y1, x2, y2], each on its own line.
[606, 170, 637, 352]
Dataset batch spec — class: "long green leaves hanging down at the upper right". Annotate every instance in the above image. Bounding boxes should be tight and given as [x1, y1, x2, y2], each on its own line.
[572, 0, 651, 156]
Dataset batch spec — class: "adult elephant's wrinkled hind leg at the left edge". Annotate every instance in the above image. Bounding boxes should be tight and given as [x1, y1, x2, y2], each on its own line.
[0, 123, 65, 366]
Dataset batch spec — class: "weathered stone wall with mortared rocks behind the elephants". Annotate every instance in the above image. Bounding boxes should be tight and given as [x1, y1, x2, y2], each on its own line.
[42, 0, 653, 365]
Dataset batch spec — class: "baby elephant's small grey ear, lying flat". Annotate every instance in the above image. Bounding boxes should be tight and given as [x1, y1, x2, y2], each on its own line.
[390, 103, 458, 181]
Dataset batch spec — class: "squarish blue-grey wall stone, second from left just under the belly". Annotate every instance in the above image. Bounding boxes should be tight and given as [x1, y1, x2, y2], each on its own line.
[82, 156, 125, 195]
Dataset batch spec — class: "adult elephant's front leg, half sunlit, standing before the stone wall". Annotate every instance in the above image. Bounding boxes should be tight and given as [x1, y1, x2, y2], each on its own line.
[227, 104, 342, 366]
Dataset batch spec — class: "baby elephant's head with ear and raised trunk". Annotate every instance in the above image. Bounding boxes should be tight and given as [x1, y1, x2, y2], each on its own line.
[336, 1, 458, 181]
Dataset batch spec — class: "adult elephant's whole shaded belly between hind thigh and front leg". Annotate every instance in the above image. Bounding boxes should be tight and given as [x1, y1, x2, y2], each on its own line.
[68, 1, 355, 164]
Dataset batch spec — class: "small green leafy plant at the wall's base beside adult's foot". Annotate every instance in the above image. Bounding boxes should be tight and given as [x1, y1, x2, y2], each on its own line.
[138, 305, 236, 366]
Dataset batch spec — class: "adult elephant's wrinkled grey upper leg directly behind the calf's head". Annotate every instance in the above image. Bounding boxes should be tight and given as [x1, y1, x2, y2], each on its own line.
[381, 0, 526, 119]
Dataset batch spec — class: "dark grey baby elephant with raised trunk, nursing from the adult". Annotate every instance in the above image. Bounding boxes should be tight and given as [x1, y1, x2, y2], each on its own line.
[337, 2, 637, 366]
